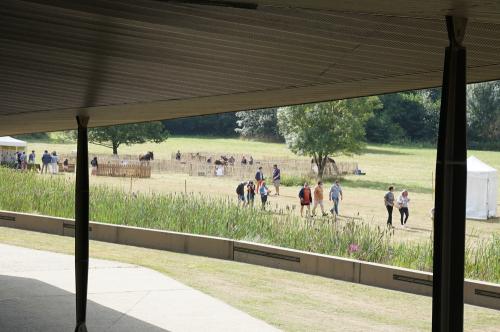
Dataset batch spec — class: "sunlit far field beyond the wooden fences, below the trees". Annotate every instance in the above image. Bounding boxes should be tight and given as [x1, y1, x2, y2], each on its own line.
[28, 137, 500, 192]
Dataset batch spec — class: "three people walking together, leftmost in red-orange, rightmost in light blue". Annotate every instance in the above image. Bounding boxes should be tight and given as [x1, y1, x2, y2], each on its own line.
[299, 181, 343, 217]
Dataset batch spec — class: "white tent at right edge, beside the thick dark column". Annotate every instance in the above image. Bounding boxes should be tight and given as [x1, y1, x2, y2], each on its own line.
[466, 156, 498, 219]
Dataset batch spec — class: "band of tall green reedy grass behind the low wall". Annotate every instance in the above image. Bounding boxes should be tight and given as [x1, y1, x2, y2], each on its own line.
[0, 168, 500, 282]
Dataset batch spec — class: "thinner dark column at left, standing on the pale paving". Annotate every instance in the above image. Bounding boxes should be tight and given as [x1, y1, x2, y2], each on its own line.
[75, 116, 89, 332]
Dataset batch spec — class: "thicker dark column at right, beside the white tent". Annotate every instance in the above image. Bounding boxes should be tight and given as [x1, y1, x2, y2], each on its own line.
[432, 16, 467, 332]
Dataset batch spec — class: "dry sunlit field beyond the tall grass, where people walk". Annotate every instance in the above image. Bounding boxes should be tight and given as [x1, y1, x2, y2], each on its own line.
[21, 137, 500, 241]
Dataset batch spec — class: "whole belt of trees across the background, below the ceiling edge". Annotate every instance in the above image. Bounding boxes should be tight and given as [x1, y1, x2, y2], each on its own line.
[14, 81, 500, 157]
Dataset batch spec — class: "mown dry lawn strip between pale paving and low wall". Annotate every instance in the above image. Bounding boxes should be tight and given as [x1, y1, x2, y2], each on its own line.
[0, 227, 500, 332]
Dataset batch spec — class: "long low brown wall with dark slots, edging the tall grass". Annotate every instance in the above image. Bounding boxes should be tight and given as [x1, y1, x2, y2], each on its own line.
[0, 210, 500, 310]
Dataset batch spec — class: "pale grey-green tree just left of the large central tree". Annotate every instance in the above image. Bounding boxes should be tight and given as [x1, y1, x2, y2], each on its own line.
[235, 108, 283, 141]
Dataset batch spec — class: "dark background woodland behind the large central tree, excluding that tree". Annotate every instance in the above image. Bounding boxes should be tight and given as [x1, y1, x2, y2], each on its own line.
[163, 81, 500, 150]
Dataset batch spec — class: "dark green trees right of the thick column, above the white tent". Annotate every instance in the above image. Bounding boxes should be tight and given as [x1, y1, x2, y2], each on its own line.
[467, 81, 500, 148]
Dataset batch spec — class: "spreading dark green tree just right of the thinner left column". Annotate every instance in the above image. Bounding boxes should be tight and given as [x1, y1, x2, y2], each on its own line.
[89, 121, 168, 154]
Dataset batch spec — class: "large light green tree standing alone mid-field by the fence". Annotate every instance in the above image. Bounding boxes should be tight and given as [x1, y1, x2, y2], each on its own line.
[278, 97, 382, 178]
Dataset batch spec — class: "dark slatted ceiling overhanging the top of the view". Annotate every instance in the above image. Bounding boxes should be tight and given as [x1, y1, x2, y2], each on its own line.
[0, 0, 500, 136]
